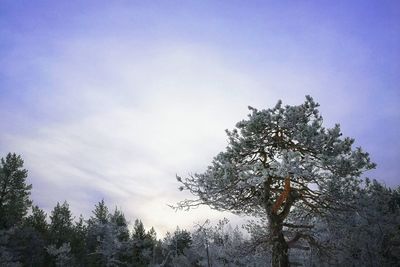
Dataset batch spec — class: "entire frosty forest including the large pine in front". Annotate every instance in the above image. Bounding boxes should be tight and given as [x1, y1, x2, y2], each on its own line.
[0, 97, 400, 267]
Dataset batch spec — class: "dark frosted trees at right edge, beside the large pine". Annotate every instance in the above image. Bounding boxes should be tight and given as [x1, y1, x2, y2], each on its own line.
[314, 179, 400, 267]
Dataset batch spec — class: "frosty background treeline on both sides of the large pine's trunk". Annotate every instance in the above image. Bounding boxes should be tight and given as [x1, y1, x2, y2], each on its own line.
[0, 153, 400, 266]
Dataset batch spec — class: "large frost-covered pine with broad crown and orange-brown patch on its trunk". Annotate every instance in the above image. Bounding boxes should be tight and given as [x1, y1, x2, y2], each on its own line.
[177, 96, 375, 267]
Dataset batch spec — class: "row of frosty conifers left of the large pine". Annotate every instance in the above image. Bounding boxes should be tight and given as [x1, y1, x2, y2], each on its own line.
[0, 153, 268, 267]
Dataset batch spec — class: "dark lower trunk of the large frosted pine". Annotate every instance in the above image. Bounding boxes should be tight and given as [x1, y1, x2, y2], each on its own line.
[270, 215, 290, 267]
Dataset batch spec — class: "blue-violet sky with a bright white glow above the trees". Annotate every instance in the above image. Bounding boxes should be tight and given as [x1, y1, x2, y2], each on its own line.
[0, 0, 400, 233]
